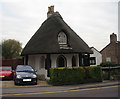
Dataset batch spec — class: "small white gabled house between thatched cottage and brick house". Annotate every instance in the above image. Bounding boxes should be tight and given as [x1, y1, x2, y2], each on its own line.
[90, 47, 102, 66]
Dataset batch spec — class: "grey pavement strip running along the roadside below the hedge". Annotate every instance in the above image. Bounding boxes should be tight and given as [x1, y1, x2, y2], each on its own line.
[0, 80, 120, 90]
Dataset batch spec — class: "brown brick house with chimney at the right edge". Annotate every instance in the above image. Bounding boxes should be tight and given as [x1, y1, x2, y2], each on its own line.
[100, 33, 120, 63]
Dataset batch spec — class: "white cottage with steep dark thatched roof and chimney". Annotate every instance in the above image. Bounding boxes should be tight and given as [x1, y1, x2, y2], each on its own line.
[21, 6, 92, 78]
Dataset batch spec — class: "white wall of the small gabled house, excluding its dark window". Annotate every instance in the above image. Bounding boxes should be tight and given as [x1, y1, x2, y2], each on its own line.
[90, 48, 102, 66]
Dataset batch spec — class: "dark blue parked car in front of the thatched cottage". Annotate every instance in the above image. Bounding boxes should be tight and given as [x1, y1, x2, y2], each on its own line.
[14, 65, 37, 85]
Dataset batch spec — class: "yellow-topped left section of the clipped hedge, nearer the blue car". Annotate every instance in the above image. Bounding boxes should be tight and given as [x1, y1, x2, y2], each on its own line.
[50, 67, 85, 85]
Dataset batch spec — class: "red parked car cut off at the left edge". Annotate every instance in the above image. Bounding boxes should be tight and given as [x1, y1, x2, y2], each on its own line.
[0, 66, 13, 80]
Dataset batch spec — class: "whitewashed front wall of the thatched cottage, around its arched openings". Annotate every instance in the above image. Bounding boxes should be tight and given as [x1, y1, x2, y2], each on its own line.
[28, 54, 79, 78]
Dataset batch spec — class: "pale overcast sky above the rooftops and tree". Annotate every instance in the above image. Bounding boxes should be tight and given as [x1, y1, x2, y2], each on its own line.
[0, 0, 120, 51]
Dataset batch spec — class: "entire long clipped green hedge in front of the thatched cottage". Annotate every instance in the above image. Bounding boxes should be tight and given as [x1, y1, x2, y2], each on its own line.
[50, 66, 102, 85]
